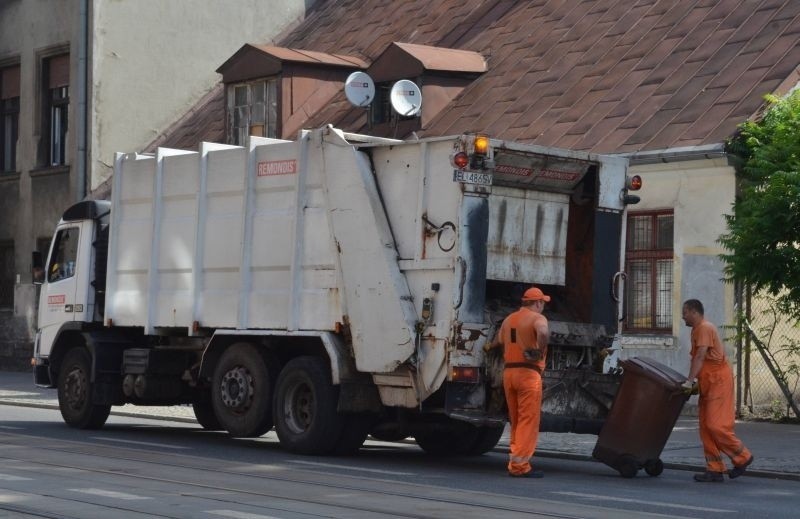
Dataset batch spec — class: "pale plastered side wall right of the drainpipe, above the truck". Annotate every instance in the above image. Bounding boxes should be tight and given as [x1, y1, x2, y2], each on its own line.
[89, 0, 314, 190]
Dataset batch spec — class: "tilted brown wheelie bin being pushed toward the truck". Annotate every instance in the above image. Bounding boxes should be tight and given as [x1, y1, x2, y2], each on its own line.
[592, 357, 688, 478]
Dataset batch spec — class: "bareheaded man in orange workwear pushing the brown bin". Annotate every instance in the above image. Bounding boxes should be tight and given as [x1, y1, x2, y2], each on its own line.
[683, 299, 753, 483]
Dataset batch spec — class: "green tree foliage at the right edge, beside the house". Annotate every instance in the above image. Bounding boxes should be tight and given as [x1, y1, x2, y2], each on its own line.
[720, 90, 800, 318]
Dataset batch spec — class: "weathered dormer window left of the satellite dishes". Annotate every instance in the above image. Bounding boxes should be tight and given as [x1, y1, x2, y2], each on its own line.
[228, 79, 278, 146]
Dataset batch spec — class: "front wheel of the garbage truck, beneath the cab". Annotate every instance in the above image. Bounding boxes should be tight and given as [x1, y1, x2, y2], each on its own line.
[58, 348, 111, 429]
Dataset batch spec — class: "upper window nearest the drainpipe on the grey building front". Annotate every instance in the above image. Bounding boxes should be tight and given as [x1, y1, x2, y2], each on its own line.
[42, 54, 69, 166]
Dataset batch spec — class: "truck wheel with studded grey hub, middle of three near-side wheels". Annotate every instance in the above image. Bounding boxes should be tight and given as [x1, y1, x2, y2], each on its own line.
[211, 343, 275, 438]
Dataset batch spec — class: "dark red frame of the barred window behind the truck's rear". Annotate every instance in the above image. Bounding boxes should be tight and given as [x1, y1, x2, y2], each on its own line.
[623, 209, 675, 333]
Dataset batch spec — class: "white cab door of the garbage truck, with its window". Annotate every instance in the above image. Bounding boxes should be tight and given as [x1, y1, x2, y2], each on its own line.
[39, 224, 85, 356]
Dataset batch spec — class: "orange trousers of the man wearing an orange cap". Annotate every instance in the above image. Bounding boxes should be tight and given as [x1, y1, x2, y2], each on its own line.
[503, 368, 542, 475]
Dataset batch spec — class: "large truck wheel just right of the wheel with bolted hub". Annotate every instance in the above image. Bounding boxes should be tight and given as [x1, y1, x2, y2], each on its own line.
[273, 356, 345, 454]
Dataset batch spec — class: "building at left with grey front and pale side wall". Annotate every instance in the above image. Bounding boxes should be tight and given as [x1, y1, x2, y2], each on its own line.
[0, 0, 313, 368]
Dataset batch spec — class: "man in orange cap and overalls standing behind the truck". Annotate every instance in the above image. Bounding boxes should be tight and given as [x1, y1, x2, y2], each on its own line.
[484, 287, 550, 478]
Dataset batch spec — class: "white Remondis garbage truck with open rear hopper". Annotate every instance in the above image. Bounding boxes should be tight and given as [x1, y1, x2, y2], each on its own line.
[31, 126, 632, 455]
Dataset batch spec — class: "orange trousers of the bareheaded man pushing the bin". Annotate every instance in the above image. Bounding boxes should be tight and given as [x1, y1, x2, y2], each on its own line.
[698, 363, 750, 472]
